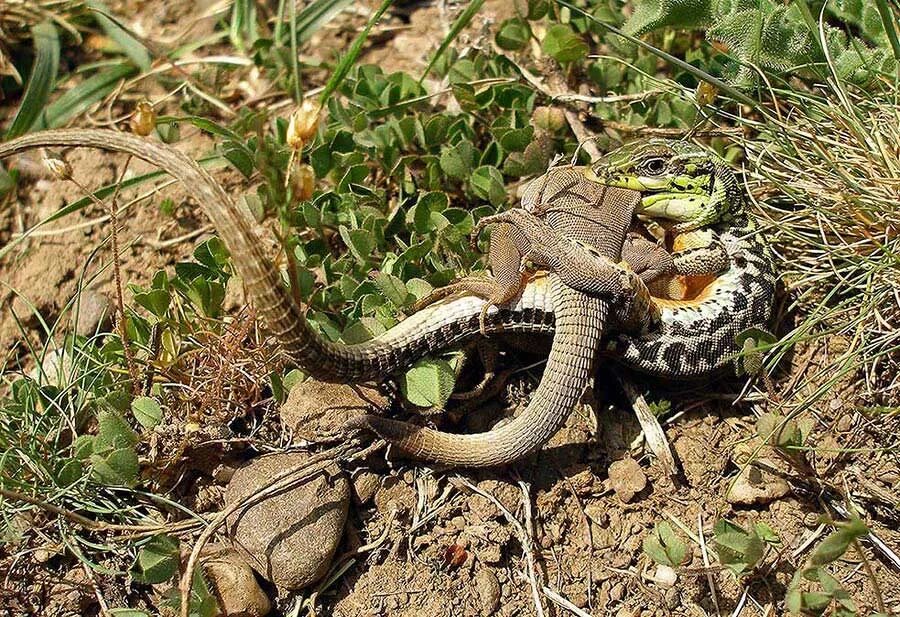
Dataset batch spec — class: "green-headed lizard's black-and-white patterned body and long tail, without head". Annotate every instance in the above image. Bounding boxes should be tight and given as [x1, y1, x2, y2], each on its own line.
[0, 130, 775, 464]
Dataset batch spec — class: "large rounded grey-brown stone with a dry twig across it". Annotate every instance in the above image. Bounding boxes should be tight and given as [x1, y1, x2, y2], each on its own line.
[225, 452, 350, 590]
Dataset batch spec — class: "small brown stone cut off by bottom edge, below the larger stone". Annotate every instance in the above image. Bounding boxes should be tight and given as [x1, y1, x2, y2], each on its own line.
[202, 545, 272, 617]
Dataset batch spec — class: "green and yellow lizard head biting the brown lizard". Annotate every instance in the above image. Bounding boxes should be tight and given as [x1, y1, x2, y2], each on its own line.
[587, 139, 743, 232]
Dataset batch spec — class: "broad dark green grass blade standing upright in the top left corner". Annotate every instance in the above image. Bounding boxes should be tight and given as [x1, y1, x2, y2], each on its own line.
[6, 21, 59, 139]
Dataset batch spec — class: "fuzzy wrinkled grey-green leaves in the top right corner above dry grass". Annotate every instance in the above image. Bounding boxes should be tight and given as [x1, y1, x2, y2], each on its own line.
[624, 0, 895, 85]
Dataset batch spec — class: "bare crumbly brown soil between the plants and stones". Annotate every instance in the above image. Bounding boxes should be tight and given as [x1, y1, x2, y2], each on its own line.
[0, 1, 900, 617]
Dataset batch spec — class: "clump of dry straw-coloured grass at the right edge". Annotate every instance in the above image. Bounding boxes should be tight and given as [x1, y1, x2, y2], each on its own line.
[744, 73, 900, 408]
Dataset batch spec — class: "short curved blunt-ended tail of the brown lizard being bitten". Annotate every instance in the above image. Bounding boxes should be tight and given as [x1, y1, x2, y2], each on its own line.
[348, 275, 610, 467]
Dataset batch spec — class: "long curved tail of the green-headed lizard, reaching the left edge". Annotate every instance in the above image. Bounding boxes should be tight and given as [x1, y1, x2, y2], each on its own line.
[0, 129, 536, 383]
